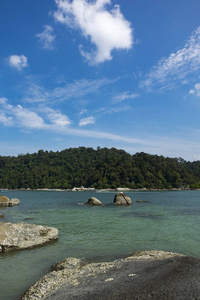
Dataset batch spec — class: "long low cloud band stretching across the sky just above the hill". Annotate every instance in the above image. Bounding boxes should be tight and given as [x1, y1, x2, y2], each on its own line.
[0, 98, 200, 159]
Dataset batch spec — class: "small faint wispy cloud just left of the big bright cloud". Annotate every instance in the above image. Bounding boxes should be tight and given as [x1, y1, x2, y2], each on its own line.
[36, 25, 56, 50]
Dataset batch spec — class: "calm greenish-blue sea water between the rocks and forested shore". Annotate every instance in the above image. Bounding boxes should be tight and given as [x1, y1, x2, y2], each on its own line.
[0, 191, 200, 300]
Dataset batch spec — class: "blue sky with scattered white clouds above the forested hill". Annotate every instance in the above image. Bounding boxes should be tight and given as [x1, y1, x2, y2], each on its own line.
[0, 0, 200, 161]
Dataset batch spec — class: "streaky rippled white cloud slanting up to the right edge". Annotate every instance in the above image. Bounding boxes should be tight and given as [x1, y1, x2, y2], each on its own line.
[140, 27, 200, 89]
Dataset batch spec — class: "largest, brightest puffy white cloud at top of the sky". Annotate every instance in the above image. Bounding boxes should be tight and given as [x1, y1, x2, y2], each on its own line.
[54, 0, 133, 65]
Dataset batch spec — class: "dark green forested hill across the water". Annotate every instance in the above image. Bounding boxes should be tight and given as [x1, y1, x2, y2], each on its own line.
[0, 147, 200, 189]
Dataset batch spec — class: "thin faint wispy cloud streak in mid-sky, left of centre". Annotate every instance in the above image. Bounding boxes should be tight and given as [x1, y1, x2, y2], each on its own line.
[24, 78, 119, 103]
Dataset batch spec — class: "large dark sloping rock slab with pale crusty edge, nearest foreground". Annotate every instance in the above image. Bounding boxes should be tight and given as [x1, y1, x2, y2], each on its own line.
[21, 251, 200, 300]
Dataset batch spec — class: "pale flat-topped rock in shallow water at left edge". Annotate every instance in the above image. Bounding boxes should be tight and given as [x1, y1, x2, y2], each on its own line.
[0, 222, 58, 252]
